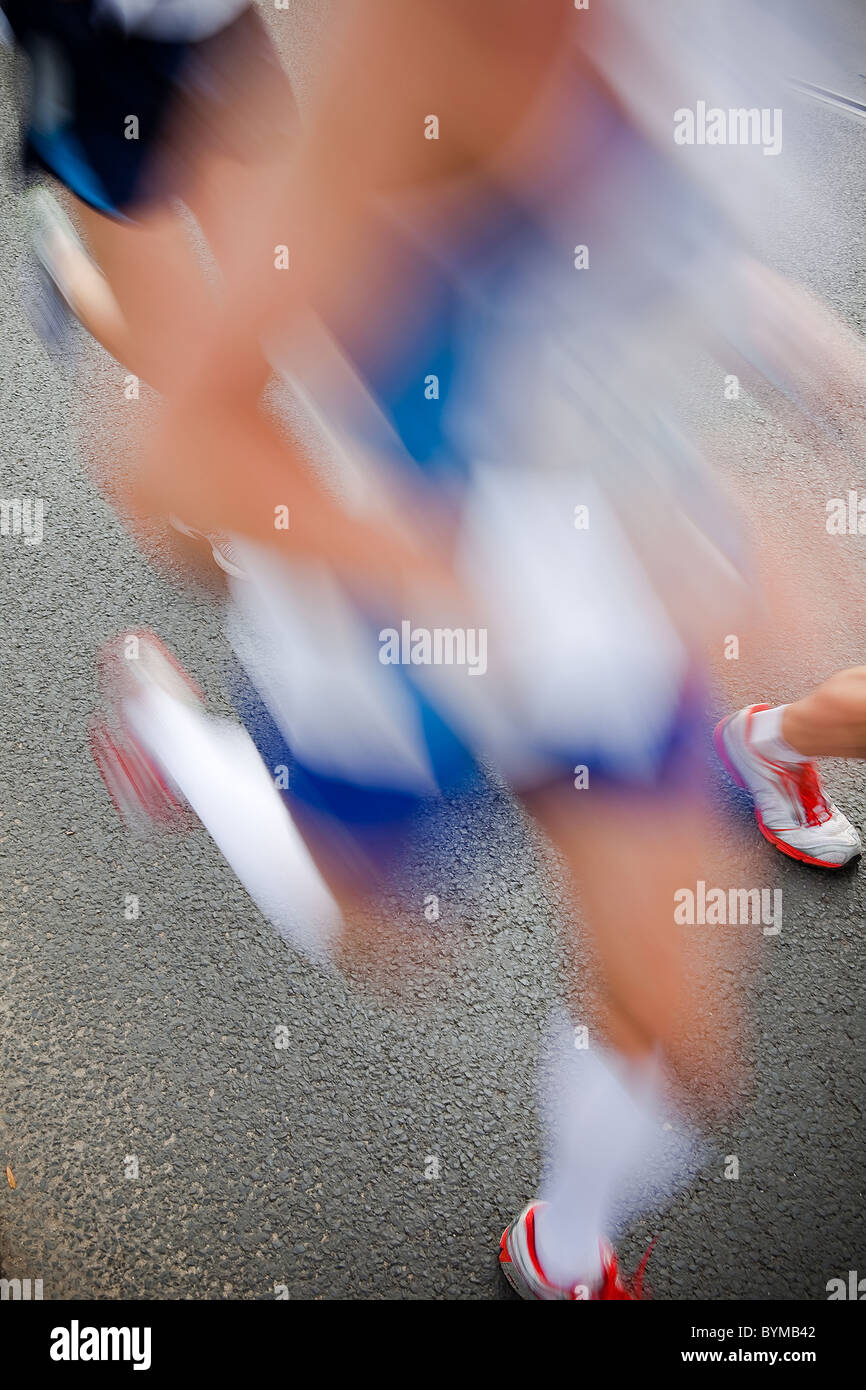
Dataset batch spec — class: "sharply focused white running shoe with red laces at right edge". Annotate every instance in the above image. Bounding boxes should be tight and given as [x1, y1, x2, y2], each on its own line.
[713, 705, 863, 869]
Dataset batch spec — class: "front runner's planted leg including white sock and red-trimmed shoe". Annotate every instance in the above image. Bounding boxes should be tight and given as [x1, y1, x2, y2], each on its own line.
[503, 788, 737, 1297]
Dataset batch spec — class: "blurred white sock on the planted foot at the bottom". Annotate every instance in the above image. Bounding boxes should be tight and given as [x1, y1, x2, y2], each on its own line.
[535, 1048, 663, 1289]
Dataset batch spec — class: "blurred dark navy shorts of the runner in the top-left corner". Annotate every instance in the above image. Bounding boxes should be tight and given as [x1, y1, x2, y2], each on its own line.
[3, 0, 291, 221]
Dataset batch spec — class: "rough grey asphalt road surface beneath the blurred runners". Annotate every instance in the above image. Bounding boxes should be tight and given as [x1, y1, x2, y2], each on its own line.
[0, 6, 866, 1300]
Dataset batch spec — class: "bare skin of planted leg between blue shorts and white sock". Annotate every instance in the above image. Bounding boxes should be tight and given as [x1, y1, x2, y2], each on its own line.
[530, 790, 738, 1108]
